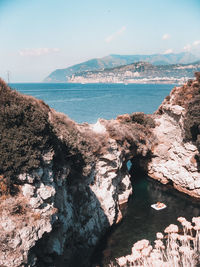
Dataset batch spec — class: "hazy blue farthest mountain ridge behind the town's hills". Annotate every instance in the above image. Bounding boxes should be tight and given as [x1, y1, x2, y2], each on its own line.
[44, 52, 198, 82]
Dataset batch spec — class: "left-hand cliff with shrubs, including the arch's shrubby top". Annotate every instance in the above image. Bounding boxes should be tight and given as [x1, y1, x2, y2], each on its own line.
[0, 81, 154, 267]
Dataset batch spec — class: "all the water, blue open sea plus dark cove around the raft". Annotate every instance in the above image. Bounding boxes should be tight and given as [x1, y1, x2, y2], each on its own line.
[10, 83, 200, 266]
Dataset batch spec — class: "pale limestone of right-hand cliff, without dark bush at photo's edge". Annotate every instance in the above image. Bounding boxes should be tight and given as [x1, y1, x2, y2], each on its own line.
[148, 77, 200, 198]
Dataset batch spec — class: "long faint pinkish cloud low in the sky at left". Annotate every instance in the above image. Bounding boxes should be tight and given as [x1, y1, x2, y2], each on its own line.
[19, 48, 60, 56]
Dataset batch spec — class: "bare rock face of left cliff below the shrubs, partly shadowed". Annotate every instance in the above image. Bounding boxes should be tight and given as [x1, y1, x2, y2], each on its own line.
[0, 139, 132, 266]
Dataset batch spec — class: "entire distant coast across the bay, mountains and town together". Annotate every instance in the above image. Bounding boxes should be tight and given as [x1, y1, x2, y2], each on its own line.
[44, 53, 200, 84]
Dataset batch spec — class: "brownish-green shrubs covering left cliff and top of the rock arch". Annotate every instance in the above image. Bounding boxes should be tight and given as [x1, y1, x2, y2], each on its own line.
[0, 80, 158, 194]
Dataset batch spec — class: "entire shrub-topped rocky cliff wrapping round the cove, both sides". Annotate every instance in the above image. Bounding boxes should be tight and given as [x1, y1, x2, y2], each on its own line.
[0, 74, 200, 267]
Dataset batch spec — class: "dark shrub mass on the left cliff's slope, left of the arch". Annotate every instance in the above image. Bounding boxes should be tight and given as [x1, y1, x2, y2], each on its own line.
[0, 80, 108, 194]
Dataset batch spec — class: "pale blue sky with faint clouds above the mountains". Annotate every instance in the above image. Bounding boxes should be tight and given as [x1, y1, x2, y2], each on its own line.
[0, 0, 200, 82]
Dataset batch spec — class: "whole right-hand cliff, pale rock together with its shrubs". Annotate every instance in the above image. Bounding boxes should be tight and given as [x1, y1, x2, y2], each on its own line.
[148, 75, 200, 198]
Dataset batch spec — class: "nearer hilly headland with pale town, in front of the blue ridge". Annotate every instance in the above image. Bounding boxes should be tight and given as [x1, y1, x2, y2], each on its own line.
[68, 61, 200, 84]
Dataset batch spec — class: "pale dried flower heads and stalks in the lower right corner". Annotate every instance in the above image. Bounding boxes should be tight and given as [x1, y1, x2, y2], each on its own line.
[110, 217, 200, 267]
